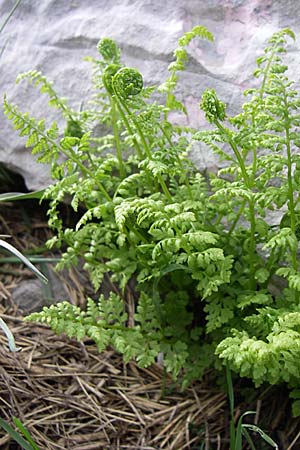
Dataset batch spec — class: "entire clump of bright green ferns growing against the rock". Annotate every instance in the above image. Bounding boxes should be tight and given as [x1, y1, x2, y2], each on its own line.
[4, 27, 300, 398]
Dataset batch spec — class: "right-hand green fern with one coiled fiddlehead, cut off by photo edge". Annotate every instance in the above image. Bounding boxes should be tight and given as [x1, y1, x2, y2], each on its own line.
[195, 29, 300, 386]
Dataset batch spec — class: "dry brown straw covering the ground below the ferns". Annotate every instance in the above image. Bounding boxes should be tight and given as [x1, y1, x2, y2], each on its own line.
[0, 309, 226, 450]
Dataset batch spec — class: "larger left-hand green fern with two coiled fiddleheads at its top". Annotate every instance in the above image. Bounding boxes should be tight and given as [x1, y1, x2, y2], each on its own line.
[4, 27, 223, 384]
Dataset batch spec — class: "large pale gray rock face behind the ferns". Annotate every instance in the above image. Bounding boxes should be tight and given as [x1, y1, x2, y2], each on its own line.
[0, 0, 300, 189]
